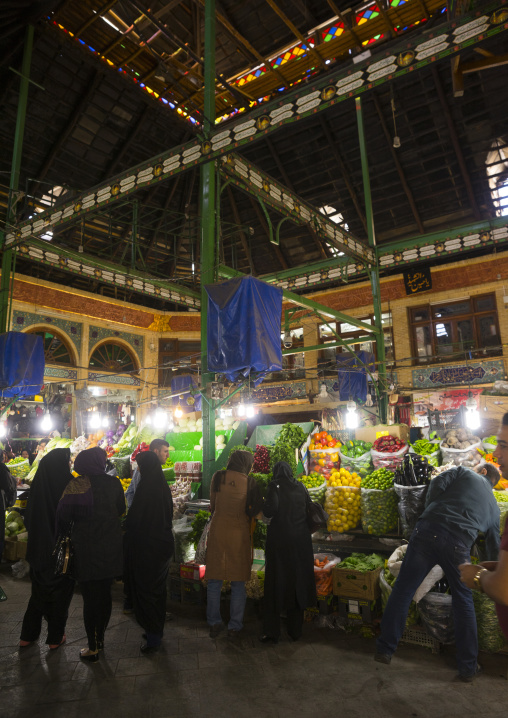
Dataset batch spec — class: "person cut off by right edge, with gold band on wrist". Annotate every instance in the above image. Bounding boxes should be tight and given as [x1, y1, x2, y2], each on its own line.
[459, 413, 508, 639]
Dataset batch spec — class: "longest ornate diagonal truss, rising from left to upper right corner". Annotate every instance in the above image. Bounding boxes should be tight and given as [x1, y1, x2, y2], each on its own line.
[6, 2, 508, 245]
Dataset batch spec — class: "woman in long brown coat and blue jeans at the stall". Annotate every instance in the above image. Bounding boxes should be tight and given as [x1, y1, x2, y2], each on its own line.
[205, 451, 263, 639]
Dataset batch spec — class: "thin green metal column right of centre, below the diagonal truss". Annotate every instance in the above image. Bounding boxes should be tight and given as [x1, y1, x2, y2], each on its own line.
[355, 97, 388, 424]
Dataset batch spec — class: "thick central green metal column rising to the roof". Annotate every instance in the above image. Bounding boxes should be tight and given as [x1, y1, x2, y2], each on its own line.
[200, 0, 216, 498]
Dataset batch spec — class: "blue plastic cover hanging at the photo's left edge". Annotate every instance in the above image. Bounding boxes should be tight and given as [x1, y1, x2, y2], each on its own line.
[0, 332, 45, 397]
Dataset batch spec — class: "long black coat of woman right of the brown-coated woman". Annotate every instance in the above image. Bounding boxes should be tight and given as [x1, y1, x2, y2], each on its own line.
[263, 479, 316, 614]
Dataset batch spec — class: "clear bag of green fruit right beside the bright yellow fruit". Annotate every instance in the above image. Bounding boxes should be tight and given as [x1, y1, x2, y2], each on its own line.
[361, 469, 398, 535]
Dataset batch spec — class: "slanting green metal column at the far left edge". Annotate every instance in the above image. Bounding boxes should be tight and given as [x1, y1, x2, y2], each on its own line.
[0, 25, 34, 334]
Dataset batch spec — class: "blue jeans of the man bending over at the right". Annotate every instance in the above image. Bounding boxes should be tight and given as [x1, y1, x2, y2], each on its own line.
[376, 520, 478, 676]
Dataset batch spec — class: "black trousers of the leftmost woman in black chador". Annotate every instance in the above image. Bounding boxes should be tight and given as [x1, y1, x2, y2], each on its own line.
[20, 568, 74, 645]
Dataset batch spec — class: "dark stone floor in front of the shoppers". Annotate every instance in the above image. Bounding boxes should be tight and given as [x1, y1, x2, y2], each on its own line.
[0, 564, 508, 718]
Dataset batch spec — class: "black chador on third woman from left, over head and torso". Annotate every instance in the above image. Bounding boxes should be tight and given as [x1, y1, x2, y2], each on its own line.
[126, 451, 173, 541]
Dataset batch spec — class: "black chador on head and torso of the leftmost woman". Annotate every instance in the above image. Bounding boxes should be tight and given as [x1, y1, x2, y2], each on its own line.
[25, 449, 72, 571]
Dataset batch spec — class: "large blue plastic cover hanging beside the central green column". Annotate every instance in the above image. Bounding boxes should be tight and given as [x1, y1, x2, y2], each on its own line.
[206, 277, 282, 386]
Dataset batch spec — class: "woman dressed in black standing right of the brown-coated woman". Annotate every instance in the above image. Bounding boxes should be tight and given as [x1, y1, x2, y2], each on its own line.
[259, 461, 316, 643]
